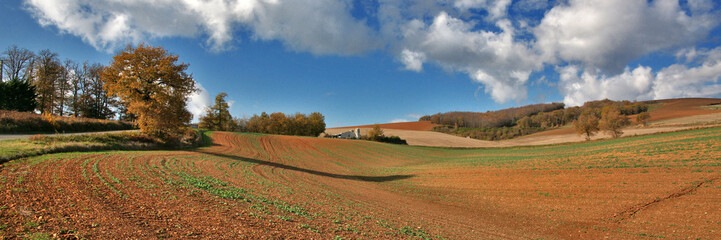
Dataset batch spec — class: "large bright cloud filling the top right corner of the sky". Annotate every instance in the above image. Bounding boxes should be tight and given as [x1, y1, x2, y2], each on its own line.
[535, 0, 721, 74]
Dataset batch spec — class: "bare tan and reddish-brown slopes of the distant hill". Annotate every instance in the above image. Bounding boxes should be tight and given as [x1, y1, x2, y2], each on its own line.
[326, 98, 721, 147]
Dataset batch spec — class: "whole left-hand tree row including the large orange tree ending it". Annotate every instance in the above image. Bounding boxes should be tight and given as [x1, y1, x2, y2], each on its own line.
[0, 44, 198, 143]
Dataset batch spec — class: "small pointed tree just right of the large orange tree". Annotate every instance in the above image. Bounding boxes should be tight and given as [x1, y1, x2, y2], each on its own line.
[198, 92, 235, 131]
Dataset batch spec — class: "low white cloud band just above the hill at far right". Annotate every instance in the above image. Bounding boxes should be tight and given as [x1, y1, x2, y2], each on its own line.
[557, 47, 721, 106]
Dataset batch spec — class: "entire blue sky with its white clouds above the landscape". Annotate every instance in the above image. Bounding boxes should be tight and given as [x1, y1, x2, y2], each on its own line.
[0, 0, 721, 127]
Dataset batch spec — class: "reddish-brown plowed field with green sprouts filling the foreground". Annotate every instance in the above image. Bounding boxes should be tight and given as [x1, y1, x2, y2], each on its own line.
[0, 128, 721, 239]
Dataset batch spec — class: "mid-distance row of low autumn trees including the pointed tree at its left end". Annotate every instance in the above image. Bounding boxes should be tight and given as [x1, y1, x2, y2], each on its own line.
[198, 93, 325, 137]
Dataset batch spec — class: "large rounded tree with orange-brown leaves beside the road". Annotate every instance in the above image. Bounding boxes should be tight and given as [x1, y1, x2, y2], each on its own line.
[100, 44, 196, 138]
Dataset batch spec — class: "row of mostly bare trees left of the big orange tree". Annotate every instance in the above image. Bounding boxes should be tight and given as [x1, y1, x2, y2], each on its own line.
[0, 45, 116, 119]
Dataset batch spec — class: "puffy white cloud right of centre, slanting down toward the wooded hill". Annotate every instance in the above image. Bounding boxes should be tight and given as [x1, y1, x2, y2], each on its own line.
[402, 12, 542, 103]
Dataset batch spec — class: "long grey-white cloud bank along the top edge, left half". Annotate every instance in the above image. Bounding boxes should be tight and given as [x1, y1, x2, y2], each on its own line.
[25, 0, 380, 55]
